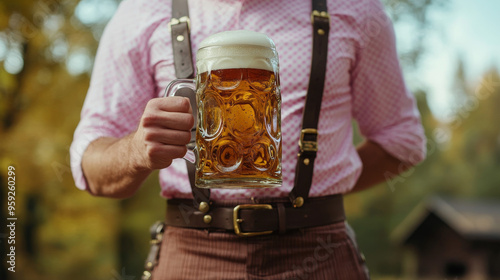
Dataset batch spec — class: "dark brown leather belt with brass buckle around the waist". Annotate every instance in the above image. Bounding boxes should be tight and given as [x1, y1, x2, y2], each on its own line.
[165, 194, 345, 236]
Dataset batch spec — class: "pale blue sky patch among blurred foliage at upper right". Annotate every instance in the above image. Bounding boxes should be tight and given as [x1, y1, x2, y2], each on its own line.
[396, 0, 500, 120]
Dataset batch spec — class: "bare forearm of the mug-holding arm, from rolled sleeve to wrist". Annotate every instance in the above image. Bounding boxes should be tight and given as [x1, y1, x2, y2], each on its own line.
[82, 135, 151, 198]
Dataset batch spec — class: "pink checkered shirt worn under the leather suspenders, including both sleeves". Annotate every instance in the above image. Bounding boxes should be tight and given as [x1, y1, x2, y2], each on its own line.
[71, 0, 425, 199]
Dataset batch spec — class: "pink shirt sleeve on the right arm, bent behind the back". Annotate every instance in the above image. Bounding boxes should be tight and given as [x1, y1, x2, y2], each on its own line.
[351, 4, 426, 165]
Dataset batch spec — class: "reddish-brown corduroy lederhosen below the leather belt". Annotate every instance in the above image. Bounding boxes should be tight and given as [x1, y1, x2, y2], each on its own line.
[152, 211, 369, 280]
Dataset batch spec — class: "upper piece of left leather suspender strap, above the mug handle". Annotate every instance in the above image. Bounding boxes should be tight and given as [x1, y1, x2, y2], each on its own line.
[172, 0, 194, 79]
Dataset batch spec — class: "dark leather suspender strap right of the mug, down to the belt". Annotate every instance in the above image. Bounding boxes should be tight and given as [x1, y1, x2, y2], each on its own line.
[289, 0, 330, 207]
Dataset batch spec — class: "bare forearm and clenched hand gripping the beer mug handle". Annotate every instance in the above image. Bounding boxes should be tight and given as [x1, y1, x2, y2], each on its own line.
[82, 97, 194, 198]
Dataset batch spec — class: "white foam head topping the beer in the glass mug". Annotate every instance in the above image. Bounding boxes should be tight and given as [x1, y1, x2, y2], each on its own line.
[196, 30, 278, 73]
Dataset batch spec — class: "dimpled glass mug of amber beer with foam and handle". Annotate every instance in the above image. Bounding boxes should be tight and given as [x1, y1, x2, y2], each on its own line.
[165, 30, 282, 188]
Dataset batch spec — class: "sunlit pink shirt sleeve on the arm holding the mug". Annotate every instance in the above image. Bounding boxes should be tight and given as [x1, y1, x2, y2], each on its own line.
[70, 1, 156, 190]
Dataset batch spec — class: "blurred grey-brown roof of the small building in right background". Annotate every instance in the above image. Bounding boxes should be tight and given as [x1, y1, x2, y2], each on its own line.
[392, 196, 500, 244]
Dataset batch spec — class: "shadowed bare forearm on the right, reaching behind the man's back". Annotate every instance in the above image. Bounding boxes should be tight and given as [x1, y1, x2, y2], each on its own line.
[351, 141, 408, 192]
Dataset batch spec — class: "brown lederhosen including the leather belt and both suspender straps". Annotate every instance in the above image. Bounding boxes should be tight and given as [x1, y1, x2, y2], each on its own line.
[142, 0, 369, 280]
